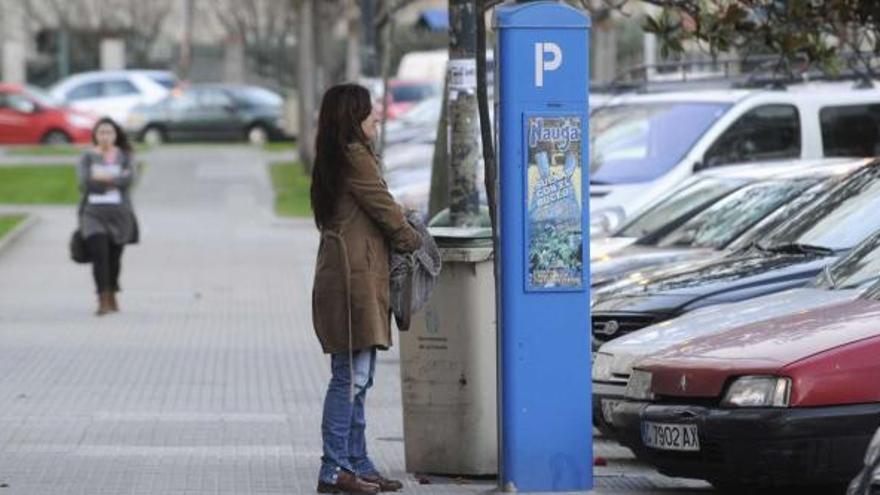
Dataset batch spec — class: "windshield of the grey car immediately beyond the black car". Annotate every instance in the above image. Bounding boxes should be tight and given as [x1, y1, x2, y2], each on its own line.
[657, 178, 818, 249]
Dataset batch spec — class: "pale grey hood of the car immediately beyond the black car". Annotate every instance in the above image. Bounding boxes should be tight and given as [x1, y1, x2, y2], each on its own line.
[590, 245, 721, 287]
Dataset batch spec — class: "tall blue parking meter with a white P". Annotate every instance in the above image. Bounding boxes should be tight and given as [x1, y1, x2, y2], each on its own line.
[495, 1, 593, 492]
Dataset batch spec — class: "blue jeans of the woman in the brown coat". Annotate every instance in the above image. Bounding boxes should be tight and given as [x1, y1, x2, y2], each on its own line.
[318, 348, 377, 483]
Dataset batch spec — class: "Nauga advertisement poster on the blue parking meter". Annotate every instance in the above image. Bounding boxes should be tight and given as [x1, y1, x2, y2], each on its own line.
[526, 116, 584, 291]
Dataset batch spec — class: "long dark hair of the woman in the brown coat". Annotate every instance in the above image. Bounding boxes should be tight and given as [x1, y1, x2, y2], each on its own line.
[311, 84, 373, 229]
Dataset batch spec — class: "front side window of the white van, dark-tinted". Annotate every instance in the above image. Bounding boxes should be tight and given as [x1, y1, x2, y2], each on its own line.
[704, 105, 801, 167]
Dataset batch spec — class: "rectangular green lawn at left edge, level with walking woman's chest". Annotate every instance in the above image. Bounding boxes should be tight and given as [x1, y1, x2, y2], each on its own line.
[0, 165, 79, 205]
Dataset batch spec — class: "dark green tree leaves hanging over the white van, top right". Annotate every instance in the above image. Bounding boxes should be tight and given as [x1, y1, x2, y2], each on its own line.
[636, 0, 880, 75]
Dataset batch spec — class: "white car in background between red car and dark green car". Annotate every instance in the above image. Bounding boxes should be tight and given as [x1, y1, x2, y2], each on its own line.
[49, 69, 177, 125]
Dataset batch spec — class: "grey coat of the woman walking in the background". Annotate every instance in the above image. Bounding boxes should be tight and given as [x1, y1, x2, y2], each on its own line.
[77, 150, 140, 245]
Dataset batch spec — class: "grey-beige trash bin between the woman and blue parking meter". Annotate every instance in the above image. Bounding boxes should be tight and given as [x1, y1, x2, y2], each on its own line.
[400, 209, 498, 476]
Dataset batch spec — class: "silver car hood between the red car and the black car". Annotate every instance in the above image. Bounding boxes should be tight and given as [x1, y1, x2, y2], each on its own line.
[599, 287, 863, 376]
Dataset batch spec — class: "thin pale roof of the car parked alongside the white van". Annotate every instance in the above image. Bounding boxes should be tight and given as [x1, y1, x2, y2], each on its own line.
[695, 158, 872, 179]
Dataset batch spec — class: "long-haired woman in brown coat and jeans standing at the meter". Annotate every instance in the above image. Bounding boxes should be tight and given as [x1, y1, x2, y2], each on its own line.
[311, 84, 421, 493]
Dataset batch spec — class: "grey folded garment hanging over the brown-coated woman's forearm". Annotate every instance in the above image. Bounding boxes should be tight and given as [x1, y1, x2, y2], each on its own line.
[390, 212, 442, 330]
